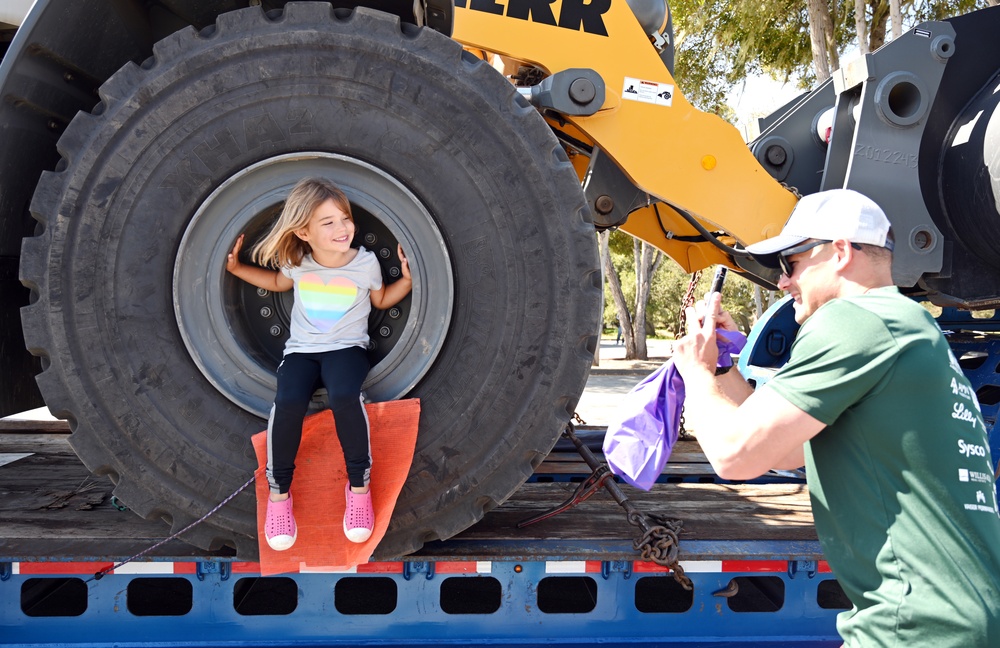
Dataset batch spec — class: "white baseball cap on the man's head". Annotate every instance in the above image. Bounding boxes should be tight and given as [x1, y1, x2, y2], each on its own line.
[747, 189, 892, 268]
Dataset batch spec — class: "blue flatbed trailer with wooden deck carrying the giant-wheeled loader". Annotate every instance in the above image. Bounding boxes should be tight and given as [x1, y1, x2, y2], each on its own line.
[0, 423, 849, 646]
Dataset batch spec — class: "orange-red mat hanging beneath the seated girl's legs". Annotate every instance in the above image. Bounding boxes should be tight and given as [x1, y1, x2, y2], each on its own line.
[253, 399, 420, 576]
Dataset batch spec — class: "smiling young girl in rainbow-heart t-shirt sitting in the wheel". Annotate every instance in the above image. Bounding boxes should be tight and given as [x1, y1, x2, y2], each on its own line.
[226, 178, 413, 551]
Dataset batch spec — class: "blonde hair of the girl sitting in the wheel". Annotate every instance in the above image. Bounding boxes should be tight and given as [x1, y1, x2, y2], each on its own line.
[250, 178, 354, 268]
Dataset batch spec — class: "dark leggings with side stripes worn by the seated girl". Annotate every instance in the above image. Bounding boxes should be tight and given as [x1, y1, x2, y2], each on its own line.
[267, 347, 372, 493]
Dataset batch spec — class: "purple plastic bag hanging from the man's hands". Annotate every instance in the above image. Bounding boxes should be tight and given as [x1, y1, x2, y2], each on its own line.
[604, 329, 747, 490]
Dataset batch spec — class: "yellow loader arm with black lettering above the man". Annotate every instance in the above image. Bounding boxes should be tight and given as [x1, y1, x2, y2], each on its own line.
[453, 0, 796, 272]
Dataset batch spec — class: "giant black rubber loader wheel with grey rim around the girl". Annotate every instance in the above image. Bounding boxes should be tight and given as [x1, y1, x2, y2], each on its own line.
[21, 3, 601, 558]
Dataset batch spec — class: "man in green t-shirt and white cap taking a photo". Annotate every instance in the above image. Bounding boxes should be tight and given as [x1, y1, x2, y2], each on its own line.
[674, 189, 1000, 648]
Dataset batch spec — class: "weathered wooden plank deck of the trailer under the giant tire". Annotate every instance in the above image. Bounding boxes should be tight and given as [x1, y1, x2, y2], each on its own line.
[0, 422, 822, 561]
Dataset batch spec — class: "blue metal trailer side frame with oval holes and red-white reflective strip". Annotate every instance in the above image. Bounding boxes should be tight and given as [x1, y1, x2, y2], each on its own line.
[0, 546, 844, 647]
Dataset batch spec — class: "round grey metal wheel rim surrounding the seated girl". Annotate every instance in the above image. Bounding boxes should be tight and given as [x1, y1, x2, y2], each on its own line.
[173, 153, 454, 418]
